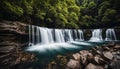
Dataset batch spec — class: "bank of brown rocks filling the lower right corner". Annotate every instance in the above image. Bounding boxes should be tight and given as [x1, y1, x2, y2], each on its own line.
[48, 43, 120, 69]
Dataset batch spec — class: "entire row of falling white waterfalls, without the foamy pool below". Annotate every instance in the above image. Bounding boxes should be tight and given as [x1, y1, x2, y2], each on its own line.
[29, 25, 117, 46]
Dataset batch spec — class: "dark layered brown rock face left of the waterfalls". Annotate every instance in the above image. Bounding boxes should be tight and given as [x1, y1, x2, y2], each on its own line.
[0, 21, 33, 69]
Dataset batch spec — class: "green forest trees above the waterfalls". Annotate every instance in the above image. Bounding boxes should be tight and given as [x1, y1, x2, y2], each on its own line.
[0, 0, 120, 29]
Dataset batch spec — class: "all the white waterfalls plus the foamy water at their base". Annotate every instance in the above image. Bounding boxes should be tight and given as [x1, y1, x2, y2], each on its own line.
[26, 25, 116, 58]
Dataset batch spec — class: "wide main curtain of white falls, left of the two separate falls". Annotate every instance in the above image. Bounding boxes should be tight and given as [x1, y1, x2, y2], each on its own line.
[29, 25, 84, 46]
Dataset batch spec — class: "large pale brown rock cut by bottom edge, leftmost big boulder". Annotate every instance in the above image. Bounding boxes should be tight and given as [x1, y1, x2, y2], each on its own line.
[67, 59, 80, 69]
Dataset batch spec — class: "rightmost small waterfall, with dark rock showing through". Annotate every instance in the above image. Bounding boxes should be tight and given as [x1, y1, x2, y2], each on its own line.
[105, 29, 117, 41]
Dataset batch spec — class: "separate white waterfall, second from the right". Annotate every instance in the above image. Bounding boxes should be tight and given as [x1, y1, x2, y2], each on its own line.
[90, 29, 103, 41]
